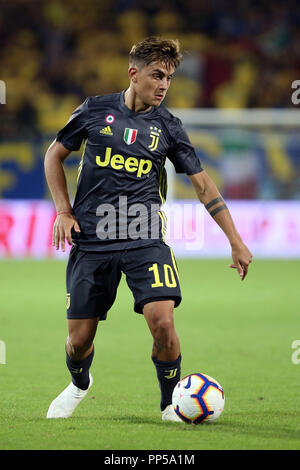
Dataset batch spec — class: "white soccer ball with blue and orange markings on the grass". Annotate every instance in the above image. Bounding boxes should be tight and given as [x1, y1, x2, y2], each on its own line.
[172, 374, 225, 424]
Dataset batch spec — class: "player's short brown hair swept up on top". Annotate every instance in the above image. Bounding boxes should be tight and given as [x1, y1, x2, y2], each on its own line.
[129, 36, 182, 68]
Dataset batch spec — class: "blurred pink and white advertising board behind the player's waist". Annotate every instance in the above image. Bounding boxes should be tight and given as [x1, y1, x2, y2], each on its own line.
[0, 200, 300, 259]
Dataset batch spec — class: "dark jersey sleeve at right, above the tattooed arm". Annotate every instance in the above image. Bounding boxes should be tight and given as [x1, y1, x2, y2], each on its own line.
[167, 118, 203, 175]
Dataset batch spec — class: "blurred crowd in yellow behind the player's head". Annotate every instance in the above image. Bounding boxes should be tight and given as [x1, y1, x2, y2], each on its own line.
[0, 0, 300, 138]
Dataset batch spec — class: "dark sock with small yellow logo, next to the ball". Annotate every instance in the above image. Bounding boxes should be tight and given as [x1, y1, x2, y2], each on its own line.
[152, 354, 181, 411]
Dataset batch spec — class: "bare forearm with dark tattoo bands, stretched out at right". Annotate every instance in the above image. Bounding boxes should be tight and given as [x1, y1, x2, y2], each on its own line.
[189, 171, 252, 280]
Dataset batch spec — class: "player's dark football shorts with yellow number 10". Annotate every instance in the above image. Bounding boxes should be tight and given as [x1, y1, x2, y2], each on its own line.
[66, 242, 181, 320]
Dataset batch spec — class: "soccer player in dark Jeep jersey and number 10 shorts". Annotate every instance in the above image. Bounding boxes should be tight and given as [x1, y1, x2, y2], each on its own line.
[45, 37, 252, 422]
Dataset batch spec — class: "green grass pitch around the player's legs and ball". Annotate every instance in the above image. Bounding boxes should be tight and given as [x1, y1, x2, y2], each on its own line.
[0, 259, 300, 451]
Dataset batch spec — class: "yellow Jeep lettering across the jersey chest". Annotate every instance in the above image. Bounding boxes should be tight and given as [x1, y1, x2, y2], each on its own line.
[96, 147, 152, 178]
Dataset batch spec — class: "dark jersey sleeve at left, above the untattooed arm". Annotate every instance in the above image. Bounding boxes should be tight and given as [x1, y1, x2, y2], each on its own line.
[56, 98, 89, 150]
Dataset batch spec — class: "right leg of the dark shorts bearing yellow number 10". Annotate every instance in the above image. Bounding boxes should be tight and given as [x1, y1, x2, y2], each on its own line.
[122, 243, 181, 313]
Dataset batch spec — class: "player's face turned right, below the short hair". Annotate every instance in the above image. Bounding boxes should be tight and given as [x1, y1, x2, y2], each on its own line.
[133, 62, 174, 106]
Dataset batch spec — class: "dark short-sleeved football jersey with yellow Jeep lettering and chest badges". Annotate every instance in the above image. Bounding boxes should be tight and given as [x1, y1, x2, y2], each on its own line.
[56, 91, 202, 251]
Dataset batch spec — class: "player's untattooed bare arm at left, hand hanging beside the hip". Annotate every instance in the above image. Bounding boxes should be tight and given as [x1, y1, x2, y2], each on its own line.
[44, 141, 80, 251]
